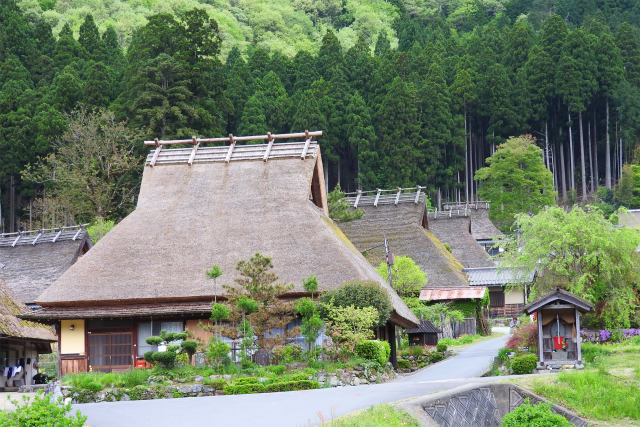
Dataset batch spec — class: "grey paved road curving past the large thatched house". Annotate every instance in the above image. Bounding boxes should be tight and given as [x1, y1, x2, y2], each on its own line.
[74, 336, 507, 427]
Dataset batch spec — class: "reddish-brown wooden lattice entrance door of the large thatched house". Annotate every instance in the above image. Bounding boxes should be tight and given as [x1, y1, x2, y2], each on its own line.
[89, 332, 133, 372]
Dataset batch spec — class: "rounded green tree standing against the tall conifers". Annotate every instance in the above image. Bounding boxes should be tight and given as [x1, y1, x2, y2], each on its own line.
[475, 136, 556, 230]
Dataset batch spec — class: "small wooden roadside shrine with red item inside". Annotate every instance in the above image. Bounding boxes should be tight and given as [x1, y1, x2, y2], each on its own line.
[524, 288, 593, 369]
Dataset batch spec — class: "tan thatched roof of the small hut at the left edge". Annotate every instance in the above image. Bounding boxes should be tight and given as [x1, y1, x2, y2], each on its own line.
[0, 278, 56, 341]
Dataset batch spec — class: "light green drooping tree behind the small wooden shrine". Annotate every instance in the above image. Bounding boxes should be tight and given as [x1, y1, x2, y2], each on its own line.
[505, 207, 640, 328]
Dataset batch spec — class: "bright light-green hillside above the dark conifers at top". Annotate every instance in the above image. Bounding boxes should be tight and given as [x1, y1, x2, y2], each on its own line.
[18, 0, 397, 56]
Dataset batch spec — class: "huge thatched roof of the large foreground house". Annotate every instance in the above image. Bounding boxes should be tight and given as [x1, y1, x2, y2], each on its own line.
[37, 142, 418, 326]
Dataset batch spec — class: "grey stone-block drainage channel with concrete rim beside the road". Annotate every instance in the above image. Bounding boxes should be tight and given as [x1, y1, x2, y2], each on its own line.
[396, 383, 589, 427]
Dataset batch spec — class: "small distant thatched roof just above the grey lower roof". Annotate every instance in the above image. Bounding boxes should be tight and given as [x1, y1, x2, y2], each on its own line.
[427, 213, 495, 267]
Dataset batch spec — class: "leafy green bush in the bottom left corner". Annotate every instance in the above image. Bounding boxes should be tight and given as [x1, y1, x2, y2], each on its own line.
[0, 391, 87, 427]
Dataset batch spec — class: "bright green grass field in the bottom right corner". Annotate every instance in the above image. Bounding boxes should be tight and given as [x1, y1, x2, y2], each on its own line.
[516, 343, 640, 425]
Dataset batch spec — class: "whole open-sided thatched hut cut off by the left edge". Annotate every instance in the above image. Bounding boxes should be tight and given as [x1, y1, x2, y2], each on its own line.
[0, 277, 56, 390]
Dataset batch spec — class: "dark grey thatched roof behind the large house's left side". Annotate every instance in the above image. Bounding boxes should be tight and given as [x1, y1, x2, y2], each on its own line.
[0, 227, 91, 304]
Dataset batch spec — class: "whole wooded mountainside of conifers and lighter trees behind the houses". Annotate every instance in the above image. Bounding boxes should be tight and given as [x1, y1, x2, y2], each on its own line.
[0, 0, 640, 232]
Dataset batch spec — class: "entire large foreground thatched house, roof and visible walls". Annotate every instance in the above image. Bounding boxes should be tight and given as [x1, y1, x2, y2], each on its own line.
[29, 133, 418, 374]
